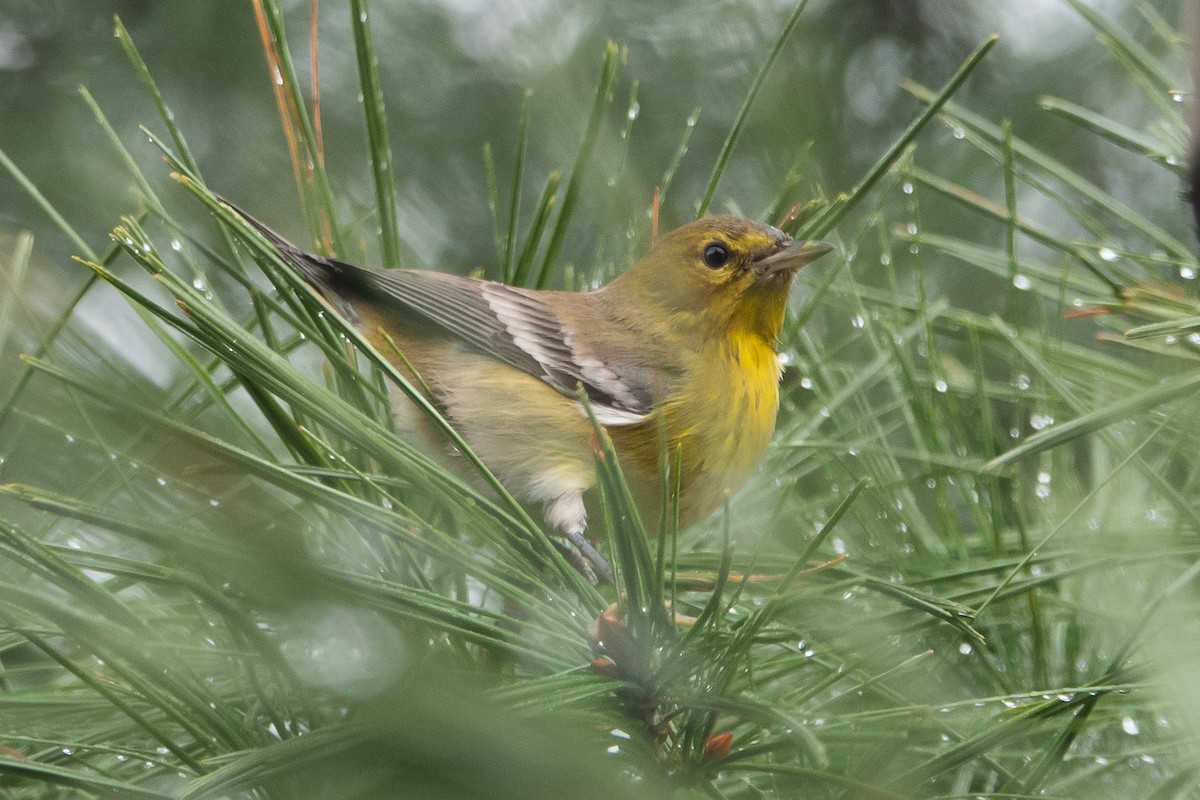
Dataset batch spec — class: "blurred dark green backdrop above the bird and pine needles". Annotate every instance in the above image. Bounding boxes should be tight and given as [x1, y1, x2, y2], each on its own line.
[0, 0, 1186, 287]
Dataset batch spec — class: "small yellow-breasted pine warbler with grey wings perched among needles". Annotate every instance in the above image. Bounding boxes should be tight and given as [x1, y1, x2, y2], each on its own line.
[225, 207, 832, 577]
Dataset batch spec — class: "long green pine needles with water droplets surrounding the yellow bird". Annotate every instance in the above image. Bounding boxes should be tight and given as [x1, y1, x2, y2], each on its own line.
[0, 0, 1200, 798]
